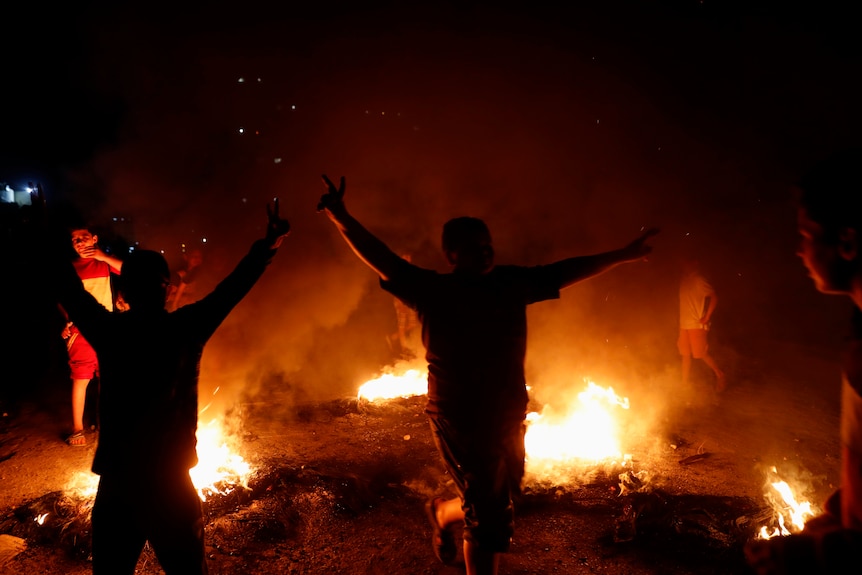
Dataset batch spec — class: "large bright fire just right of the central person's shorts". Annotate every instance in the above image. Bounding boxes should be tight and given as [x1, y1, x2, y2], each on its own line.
[524, 381, 629, 484]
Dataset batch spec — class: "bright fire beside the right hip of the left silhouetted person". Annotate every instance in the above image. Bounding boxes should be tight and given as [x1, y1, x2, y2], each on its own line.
[189, 419, 252, 501]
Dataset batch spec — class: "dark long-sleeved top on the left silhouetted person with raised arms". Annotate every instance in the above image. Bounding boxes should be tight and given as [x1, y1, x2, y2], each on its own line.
[56, 241, 275, 475]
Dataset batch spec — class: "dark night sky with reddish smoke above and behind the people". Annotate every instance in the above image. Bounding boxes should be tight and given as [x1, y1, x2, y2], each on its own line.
[5, 0, 862, 410]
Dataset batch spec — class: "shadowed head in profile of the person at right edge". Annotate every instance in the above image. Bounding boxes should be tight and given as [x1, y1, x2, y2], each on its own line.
[797, 148, 862, 293]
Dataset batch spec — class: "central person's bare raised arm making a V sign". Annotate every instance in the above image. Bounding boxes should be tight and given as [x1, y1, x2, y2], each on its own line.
[317, 175, 402, 281]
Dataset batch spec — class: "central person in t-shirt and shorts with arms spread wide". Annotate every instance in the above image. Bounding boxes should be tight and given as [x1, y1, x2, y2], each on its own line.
[318, 176, 657, 575]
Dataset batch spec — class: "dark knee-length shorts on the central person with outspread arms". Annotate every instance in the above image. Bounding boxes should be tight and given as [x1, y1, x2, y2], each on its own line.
[428, 413, 527, 553]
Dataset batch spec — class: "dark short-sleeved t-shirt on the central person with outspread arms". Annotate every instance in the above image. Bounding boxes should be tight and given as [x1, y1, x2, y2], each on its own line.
[380, 262, 561, 424]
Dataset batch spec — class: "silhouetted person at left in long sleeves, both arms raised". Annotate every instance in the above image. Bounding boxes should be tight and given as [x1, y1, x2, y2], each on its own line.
[56, 200, 290, 575]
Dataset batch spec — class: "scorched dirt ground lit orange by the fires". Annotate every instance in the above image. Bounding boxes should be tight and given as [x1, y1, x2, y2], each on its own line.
[0, 344, 840, 575]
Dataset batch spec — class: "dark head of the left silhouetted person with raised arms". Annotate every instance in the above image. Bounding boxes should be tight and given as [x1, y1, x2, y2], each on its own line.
[120, 250, 171, 310]
